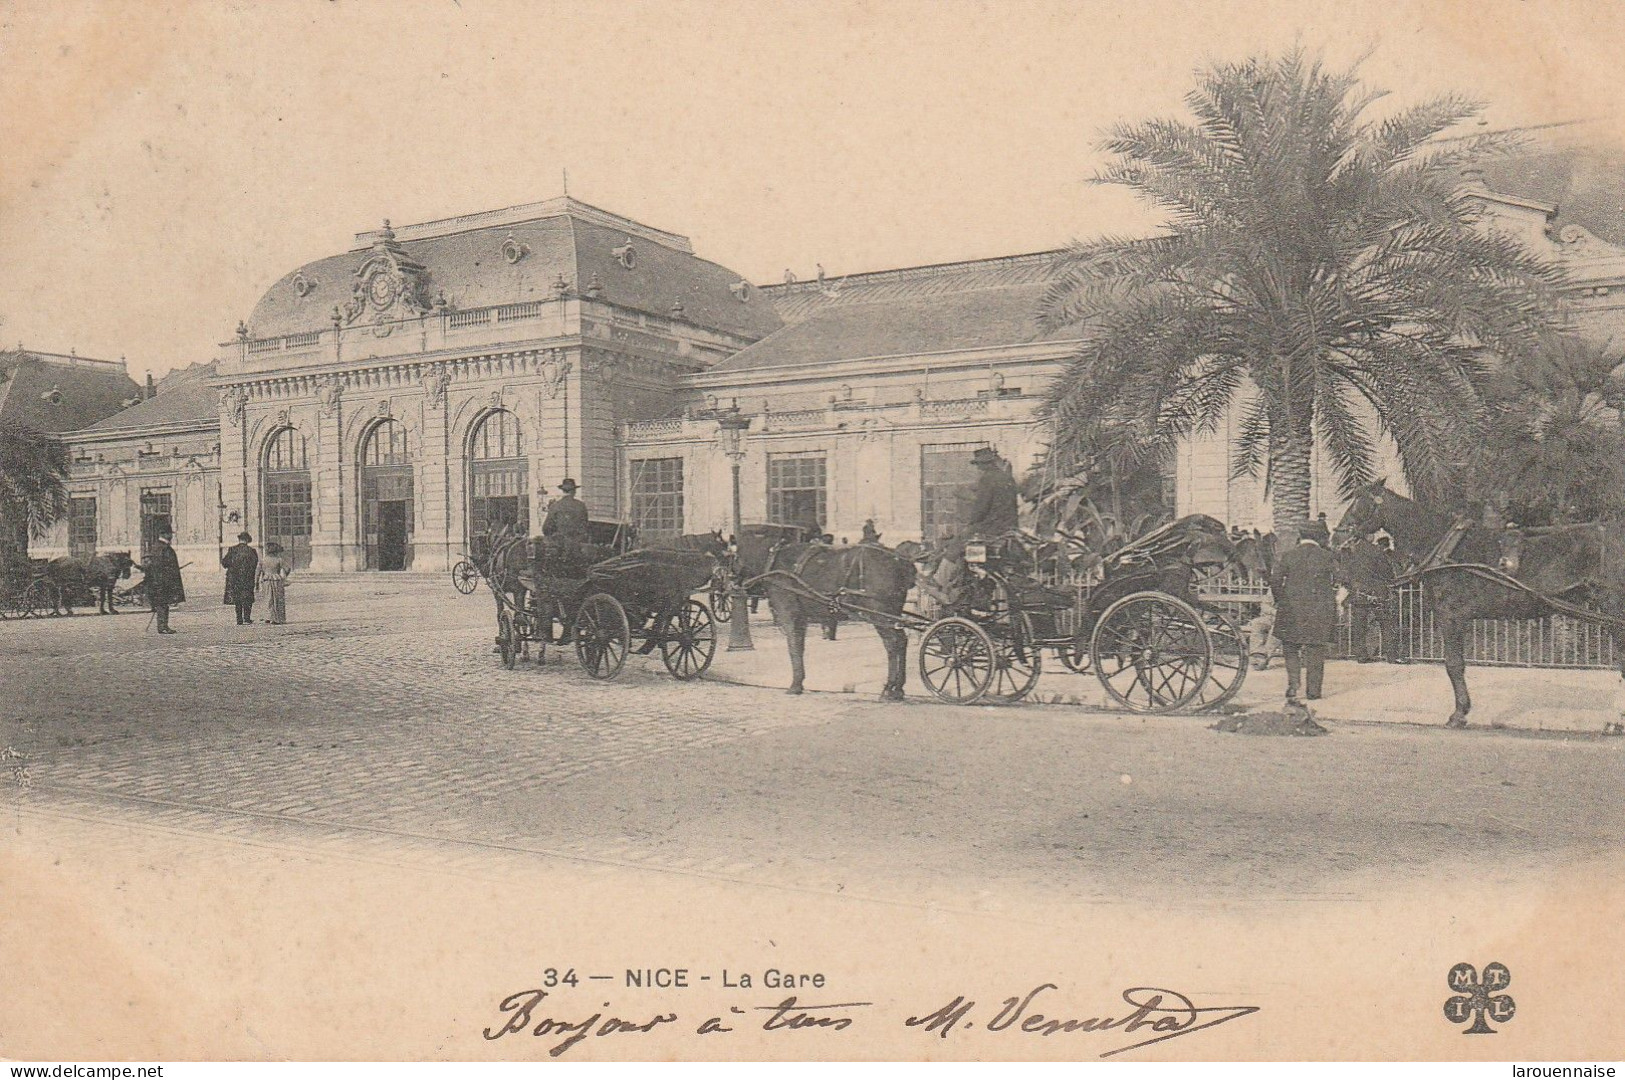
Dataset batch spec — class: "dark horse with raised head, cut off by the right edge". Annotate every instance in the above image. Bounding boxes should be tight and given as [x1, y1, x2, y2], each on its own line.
[1337, 481, 1625, 728]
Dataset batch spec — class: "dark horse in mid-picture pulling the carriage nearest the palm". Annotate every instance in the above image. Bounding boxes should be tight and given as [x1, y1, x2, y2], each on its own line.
[739, 542, 915, 702]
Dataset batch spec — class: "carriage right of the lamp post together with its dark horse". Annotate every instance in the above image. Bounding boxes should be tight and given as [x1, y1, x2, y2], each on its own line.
[746, 515, 1248, 713]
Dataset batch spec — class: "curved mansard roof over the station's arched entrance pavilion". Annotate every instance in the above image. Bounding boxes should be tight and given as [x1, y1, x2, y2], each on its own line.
[249, 197, 780, 339]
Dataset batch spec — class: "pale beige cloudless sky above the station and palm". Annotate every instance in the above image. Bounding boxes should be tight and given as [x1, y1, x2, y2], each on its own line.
[0, 0, 1625, 378]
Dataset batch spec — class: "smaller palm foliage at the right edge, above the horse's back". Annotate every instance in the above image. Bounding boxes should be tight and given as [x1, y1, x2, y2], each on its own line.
[1466, 335, 1625, 526]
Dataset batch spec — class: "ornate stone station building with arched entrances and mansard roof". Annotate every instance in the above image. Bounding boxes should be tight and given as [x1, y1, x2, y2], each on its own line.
[33, 142, 1625, 572]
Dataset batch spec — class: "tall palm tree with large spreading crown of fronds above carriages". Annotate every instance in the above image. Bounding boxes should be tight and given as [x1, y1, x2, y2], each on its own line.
[1040, 50, 1558, 525]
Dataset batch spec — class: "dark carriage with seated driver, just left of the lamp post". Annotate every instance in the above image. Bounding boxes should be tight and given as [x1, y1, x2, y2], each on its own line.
[484, 521, 717, 679]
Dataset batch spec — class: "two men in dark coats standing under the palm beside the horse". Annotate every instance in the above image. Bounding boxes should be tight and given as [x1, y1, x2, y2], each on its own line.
[1248, 515, 1409, 705]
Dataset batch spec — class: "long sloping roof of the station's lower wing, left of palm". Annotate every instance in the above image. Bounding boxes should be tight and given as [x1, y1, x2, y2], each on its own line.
[713, 252, 1069, 372]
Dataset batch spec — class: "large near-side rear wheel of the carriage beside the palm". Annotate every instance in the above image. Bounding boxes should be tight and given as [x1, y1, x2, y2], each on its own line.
[1089, 593, 1212, 713]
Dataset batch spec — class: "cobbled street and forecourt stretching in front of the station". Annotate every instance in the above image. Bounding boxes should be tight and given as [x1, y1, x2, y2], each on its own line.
[0, 580, 1625, 905]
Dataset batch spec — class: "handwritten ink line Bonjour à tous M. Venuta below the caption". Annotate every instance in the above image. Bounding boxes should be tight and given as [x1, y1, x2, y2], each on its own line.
[484, 983, 1258, 1057]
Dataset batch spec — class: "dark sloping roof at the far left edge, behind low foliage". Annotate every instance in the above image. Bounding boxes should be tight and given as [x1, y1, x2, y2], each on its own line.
[0, 349, 140, 434]
